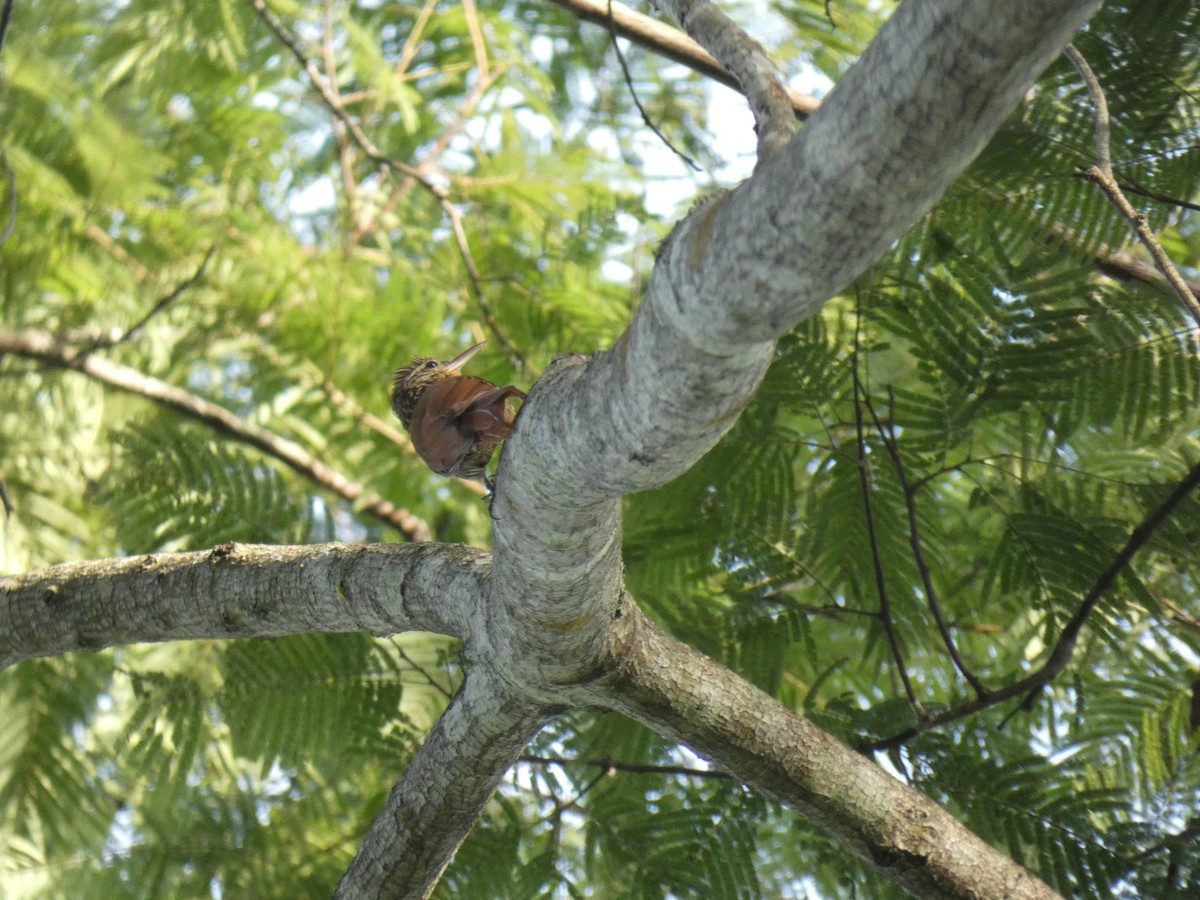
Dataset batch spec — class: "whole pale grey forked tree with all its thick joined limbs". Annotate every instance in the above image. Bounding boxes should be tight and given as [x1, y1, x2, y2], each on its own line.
[0, 0, 1098, 898]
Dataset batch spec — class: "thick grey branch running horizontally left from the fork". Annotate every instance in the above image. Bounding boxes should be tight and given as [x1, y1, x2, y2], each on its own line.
[0, 544, 488, 668]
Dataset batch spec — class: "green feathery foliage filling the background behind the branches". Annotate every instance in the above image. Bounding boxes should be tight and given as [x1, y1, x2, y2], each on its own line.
[0, 0, 1200, 899]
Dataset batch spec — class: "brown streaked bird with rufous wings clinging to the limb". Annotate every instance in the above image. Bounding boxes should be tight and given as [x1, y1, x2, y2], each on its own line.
[391, 341, 526, 491]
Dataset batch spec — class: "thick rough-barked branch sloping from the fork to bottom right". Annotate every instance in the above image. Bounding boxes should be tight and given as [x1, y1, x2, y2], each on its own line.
[589, 607, 1058, 900]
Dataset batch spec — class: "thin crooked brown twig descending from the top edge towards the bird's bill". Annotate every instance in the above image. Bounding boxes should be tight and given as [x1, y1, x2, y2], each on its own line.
[250, 0, 530, 372]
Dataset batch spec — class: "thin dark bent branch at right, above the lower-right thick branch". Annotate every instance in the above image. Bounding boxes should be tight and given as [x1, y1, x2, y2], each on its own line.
[859, 463, 1200, 752]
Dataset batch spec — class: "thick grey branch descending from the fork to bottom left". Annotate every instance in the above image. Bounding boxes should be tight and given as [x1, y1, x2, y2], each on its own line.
[334, 668, 553, 900]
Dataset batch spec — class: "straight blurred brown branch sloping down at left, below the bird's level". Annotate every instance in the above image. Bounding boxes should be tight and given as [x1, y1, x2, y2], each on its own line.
[0, 329, 431, 541]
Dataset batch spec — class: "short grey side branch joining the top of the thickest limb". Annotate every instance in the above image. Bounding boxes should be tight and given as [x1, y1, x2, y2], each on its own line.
[660, 0, 796, 164]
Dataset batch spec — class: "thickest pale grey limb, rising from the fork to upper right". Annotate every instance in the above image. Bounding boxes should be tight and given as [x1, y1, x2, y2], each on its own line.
[493, 0, 1097, 600]
